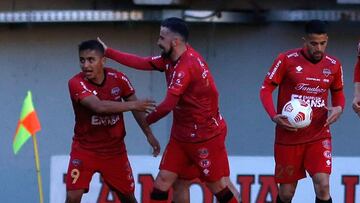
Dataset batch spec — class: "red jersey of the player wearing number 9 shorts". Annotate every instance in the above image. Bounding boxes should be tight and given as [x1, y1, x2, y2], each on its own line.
[69, 68, 135, 155]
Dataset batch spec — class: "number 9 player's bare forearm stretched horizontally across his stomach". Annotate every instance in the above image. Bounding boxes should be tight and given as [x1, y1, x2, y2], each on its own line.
[80, 95, 155, 114]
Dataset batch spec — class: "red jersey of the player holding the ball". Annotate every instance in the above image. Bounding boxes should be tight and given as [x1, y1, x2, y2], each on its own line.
[263, 49, 343, 144]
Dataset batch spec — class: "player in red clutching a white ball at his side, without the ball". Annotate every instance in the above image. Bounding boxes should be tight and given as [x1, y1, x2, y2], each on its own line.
[260, 20, 345, 203]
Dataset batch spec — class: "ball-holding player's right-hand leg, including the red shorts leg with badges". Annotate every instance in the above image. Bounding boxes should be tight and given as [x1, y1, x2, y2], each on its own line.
[305, 139, 332, 203]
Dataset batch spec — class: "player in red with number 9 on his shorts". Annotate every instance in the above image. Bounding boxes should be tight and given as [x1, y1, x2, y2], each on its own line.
[66, 40, 160, 203]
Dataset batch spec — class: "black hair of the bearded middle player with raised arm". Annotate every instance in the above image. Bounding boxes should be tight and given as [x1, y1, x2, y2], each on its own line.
[161, 17, 189, 42]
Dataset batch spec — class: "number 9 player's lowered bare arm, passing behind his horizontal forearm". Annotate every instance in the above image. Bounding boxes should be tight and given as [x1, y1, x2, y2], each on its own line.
[126, 94, 160, 157]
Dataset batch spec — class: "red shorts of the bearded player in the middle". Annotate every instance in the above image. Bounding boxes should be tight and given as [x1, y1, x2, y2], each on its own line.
[160, 129, 230, 182]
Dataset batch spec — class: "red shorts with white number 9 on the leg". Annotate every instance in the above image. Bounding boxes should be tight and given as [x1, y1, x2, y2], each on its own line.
[66, 149, 135, 195]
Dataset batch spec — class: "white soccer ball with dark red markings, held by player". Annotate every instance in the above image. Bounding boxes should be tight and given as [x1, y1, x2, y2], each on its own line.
[281, 99, 312, 128]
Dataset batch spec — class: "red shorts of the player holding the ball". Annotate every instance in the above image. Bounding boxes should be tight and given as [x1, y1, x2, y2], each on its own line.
[274, 138, 332, 183]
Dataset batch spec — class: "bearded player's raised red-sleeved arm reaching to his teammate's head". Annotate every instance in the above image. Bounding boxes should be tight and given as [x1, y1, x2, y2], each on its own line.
[97, 37, 154, 71]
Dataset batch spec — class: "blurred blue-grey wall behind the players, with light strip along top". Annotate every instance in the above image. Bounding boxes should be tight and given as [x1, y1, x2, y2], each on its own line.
[0, 0, 360, 202]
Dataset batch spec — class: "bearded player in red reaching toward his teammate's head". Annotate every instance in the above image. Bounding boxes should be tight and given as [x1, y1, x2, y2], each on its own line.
[98, 18, 238, 203]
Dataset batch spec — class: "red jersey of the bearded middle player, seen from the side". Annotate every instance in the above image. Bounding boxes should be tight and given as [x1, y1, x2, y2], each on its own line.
[149, 45, 226, 142]
